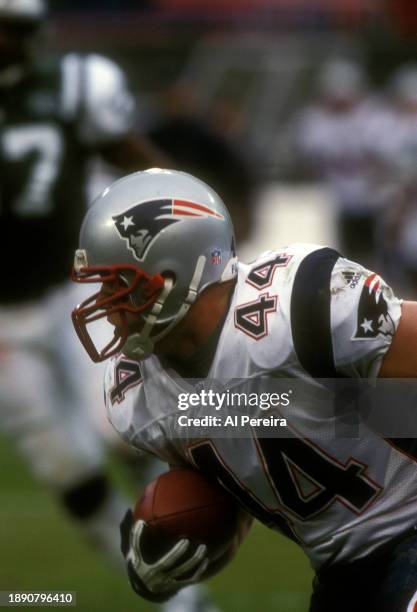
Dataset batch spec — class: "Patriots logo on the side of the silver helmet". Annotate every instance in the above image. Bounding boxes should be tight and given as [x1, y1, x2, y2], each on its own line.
[112, 199, 224, 261]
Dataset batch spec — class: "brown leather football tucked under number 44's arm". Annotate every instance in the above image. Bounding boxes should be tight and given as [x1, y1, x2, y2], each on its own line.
[134, 468, 239, 559]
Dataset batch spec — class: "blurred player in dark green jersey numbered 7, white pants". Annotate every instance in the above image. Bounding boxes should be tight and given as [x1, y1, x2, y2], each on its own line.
[0, 0, 169, 576]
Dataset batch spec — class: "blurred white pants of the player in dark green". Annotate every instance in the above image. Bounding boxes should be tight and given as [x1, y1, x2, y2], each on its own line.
[0, 283, 109, 490]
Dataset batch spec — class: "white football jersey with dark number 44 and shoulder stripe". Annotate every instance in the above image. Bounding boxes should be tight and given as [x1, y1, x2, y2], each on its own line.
[105, 244, 417, 567]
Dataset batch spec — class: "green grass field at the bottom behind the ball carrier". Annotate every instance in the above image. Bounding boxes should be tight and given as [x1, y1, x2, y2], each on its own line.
[0, 432, 311, 612]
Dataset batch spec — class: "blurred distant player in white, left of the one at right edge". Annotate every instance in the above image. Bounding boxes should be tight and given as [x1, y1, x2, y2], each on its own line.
[294, 59, 382, 265]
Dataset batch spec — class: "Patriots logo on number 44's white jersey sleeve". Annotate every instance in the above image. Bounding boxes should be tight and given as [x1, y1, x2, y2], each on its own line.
[354, 273, 395, 340]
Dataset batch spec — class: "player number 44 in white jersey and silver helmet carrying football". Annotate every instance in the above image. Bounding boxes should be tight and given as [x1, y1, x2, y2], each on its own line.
[73, 169, 417, 612]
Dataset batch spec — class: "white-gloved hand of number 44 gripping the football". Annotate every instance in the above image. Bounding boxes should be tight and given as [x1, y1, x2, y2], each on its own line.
[120, 510, 209, 602]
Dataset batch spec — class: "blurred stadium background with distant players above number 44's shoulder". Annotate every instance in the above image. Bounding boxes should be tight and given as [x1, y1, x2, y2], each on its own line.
[49, 0, 417, 297]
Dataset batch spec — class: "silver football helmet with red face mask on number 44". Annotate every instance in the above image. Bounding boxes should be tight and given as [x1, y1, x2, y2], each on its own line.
[72, 168, 237, 362]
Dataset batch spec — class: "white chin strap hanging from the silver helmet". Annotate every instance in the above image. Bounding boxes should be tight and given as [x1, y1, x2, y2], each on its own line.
[122, 255, 206, 361]
